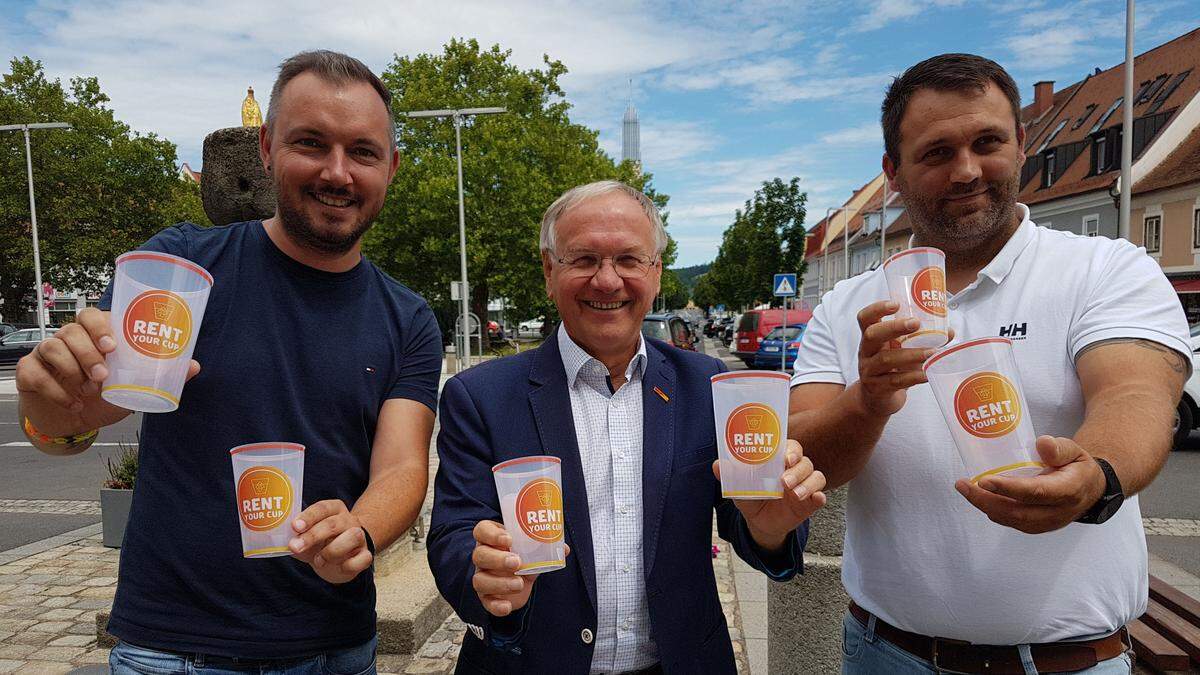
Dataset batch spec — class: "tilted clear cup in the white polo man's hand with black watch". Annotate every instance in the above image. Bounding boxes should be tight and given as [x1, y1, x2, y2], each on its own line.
[923, 338, 1045, 483]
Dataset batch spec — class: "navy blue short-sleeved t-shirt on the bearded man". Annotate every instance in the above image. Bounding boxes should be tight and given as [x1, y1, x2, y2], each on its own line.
[101, 221, 442, 658]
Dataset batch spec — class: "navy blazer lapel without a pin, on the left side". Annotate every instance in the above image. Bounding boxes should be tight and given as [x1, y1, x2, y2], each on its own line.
[529, 327, 596, 611]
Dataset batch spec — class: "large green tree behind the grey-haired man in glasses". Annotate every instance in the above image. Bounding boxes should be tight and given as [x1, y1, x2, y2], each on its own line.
[365, 40, 678, 338]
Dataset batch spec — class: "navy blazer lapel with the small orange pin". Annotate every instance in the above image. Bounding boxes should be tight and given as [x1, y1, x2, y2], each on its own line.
[642, 341, 679, 579]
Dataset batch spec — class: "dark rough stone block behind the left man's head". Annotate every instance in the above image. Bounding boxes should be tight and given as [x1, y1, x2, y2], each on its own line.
[200, 126, 275, 225]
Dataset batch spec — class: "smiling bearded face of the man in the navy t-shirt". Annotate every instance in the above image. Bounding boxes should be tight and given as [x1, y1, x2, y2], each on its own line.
[260, 72, 398, 256]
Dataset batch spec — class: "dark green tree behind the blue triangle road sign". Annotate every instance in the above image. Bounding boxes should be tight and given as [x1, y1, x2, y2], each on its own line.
[697, 178, 808, 307]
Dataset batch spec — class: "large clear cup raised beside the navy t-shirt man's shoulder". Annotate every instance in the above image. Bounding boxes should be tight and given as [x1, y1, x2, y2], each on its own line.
[100, 251, 212, 412]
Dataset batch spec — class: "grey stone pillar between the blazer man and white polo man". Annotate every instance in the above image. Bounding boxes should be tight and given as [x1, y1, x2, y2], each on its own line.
[767, 486, 850, 674]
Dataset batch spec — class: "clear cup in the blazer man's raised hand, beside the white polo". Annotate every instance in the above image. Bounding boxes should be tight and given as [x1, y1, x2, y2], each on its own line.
[712, 370, 791, 500]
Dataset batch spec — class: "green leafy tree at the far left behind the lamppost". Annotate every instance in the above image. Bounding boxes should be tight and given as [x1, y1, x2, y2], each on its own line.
[0, 58, 208, 317]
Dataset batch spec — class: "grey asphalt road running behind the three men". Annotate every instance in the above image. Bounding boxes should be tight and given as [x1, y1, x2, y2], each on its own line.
[0, 339, 1200, 577]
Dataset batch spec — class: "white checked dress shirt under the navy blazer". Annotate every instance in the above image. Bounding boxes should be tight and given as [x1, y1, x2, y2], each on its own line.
[558, 327, 659, 674]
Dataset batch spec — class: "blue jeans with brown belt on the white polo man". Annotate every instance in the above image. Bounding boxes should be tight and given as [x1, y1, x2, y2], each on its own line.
[841, 611, 1133, 675]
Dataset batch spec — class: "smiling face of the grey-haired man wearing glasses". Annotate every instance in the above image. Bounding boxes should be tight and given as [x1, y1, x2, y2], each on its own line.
[541, 192, 662, 366]
